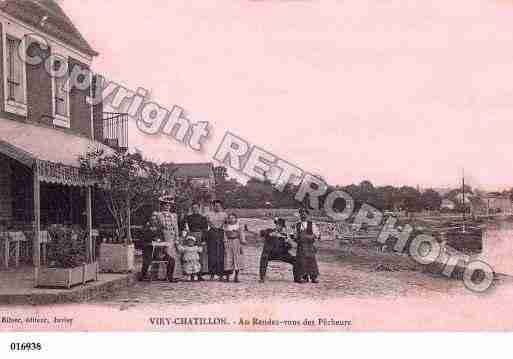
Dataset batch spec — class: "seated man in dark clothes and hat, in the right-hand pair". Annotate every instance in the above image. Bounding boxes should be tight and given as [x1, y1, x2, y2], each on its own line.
[260, 218, 299, 283]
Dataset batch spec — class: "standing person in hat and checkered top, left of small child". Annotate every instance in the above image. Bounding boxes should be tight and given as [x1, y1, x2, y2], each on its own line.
[154, 195, 183, 279]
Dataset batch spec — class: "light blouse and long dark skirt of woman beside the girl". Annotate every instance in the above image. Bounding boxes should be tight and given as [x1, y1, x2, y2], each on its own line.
[207, 212, 228, 275]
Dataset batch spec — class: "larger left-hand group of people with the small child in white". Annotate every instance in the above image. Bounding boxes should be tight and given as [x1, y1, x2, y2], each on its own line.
[141, 197, 245, 282]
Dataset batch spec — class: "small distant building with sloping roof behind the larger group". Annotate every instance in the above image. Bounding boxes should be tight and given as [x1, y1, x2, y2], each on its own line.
[164, 162, 216, 197]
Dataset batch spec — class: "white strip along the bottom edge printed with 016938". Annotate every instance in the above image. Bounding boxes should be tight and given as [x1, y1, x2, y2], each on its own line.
[0, 334, 513, 359]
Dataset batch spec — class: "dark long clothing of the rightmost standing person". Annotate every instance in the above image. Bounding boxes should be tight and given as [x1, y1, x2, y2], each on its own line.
[295, 221, 319, 278]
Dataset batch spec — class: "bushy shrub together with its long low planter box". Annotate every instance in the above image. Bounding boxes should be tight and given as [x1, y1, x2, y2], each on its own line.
[36, 227, 98, 288]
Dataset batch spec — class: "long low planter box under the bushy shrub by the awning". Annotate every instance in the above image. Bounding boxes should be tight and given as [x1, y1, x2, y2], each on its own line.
[36, 262, 98, 288]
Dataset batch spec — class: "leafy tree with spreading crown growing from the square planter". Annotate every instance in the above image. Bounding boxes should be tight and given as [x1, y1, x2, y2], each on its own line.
[80, 150, 174, 244]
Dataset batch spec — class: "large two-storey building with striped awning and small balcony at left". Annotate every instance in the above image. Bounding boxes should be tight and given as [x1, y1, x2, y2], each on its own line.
[0, 0, 127, 266]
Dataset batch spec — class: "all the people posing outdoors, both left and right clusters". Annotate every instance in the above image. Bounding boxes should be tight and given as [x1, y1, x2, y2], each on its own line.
[140, 196, 320, 283]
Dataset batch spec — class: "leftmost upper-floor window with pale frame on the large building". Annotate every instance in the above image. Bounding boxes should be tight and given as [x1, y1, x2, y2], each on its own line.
[4, 34, 27, 116]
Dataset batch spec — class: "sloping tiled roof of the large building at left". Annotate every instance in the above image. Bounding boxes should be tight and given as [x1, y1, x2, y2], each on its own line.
[0, 0, 98, 56]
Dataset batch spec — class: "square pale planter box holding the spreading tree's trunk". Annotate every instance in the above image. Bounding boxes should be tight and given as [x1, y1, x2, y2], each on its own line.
[100, 243, 135, 273]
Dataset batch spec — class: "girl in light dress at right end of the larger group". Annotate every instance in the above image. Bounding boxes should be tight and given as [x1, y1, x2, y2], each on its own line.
[224, 213, 246, 283]
